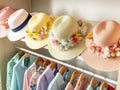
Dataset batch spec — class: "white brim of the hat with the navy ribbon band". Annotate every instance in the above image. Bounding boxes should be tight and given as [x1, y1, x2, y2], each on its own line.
[7, 25, 27, 41]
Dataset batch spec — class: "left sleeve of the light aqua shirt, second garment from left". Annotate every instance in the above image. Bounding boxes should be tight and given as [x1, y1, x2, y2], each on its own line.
[11, 69, 19, 90]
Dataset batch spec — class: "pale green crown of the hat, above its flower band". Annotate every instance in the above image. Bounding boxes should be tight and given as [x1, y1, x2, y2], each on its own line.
[52, 15, 78, 41]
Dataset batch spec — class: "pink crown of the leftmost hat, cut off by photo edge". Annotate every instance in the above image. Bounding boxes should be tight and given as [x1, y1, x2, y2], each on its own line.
[0, 6, 14, 21]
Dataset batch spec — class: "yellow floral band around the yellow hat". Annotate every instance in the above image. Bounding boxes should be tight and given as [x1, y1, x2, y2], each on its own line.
[26, 16, 56, 40]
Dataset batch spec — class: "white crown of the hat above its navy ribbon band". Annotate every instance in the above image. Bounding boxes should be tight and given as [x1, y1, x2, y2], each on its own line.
[8, 9, 28, 29]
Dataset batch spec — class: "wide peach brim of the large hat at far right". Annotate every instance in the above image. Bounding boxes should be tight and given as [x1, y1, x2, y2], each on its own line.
[81, 48, 120, 72]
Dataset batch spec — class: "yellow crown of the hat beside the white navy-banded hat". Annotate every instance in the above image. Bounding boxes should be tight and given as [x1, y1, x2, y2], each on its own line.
[28, 13, 50, 33]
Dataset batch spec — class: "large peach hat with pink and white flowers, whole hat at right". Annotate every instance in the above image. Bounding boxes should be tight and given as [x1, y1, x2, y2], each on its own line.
[82, 20, 120, 72]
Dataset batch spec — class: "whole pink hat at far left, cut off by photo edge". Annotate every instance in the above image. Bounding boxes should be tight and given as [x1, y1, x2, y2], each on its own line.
[0, 6, 14, 38]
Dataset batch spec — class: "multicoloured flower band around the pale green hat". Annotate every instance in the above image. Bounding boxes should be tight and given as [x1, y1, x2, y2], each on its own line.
[50, 30, 82, 50]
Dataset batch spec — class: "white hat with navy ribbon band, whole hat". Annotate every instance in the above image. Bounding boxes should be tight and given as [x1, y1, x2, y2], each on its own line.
[8, 9, 31, 41]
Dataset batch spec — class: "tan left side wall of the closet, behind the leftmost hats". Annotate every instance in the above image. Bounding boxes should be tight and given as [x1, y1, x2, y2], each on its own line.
[0, 0, 31, 90]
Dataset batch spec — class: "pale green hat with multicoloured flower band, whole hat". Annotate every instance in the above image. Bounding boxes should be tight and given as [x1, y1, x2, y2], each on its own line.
[48, 15, 91, 60]
